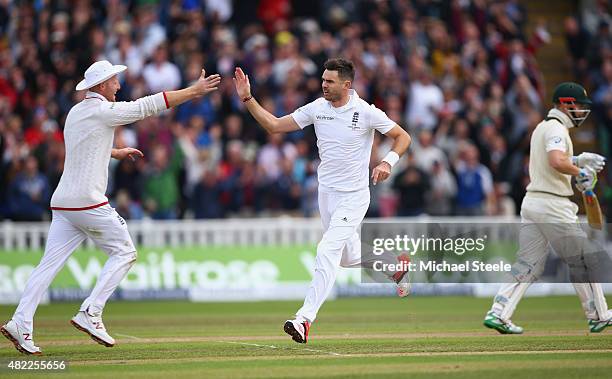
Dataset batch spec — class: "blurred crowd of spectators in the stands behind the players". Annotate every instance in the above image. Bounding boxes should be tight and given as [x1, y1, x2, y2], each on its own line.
[0, 0, 612, 220]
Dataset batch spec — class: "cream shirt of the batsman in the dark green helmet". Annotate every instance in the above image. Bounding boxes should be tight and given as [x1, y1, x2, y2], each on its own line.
[527, 109, 574, 196]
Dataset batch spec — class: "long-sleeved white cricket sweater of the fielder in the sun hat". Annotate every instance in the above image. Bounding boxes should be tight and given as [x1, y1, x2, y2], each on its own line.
[51, 91, 168, 210]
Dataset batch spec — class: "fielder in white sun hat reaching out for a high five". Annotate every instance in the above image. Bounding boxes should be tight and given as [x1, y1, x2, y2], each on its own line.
[0, 61, 221, 354]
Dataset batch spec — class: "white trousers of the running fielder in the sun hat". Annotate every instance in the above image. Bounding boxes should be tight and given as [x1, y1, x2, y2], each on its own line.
[13, 204, 136, 330]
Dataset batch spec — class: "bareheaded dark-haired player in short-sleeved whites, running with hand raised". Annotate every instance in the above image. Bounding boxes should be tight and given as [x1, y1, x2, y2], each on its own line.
[234, 59, 410, 343]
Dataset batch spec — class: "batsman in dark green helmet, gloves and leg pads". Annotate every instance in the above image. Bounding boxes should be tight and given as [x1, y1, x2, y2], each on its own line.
[484, 82, 612, 334]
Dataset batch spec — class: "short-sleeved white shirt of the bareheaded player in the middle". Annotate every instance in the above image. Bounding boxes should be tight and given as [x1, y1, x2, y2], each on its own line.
[291, 90, 396, 192]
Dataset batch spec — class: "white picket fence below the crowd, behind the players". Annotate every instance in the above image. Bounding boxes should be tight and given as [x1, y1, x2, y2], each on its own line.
[0, 216, 520, 251]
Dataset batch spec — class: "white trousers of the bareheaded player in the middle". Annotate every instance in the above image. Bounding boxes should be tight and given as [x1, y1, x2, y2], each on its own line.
[296, 186, 370, 322]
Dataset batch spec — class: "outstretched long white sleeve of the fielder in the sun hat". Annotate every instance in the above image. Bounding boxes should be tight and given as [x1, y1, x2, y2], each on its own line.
[99, 92, 169, 127]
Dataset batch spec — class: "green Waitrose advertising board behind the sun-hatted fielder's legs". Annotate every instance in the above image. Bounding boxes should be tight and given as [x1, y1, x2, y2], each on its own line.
[0, 246, 368, 304]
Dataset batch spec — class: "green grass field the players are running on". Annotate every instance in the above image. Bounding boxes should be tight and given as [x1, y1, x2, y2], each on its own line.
[0, 297, 612, 379]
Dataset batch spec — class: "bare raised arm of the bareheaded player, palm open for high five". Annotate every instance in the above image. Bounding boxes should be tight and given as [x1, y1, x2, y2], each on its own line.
[234, 67, 300, 133]
